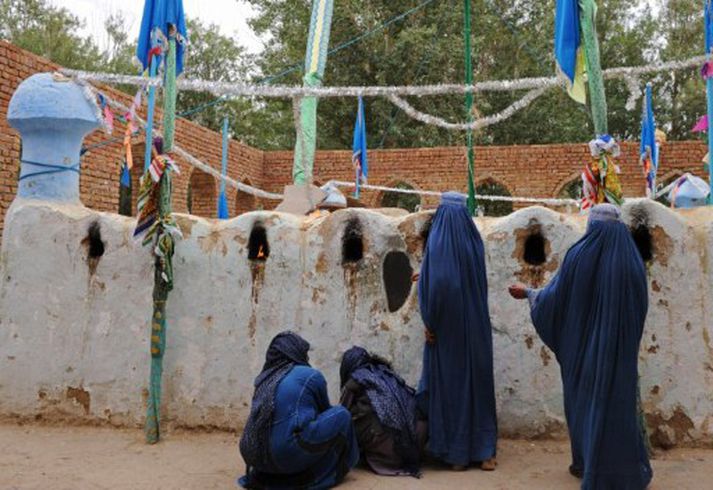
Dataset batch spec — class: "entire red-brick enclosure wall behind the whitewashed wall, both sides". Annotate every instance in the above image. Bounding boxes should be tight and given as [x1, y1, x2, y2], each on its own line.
[0, 41, 706, 239]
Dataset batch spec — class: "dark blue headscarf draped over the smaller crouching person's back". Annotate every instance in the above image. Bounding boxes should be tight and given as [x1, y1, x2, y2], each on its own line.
[339, 346, 420, 475]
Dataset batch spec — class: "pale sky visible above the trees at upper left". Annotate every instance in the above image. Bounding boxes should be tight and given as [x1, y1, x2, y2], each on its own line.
[49, 0, 263, 53]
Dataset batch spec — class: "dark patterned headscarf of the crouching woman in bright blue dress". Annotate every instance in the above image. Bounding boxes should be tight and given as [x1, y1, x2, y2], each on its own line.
[240, 331, 310, 473]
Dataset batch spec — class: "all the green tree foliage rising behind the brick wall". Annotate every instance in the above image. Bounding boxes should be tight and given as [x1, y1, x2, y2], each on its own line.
[0, 0, 705, 153]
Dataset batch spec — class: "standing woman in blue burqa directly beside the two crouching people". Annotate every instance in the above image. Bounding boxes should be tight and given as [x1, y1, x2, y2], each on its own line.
[418, 192, 497, 470]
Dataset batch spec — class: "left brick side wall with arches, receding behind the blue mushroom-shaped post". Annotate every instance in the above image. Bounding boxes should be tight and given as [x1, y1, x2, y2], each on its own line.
[0, 41, 263, 237]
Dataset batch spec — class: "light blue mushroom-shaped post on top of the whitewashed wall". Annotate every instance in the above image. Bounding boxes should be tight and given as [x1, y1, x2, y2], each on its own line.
[7, 73, 100, 203]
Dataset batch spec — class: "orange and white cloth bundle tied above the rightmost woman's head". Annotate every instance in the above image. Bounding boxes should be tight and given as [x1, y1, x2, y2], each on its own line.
[581, 134, 623, 210]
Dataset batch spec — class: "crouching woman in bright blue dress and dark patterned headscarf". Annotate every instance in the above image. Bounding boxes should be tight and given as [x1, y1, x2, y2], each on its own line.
[239, 332, 359, 489]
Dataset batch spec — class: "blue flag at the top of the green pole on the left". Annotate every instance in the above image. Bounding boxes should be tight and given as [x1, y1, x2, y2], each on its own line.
[136, 0, 186, 76]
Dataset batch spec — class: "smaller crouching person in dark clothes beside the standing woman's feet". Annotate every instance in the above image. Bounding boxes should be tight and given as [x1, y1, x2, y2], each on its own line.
[339, 347, 426, 477]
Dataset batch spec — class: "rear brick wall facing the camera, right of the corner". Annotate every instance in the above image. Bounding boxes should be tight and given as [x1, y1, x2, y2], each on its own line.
[264, 141, 707, 211]
